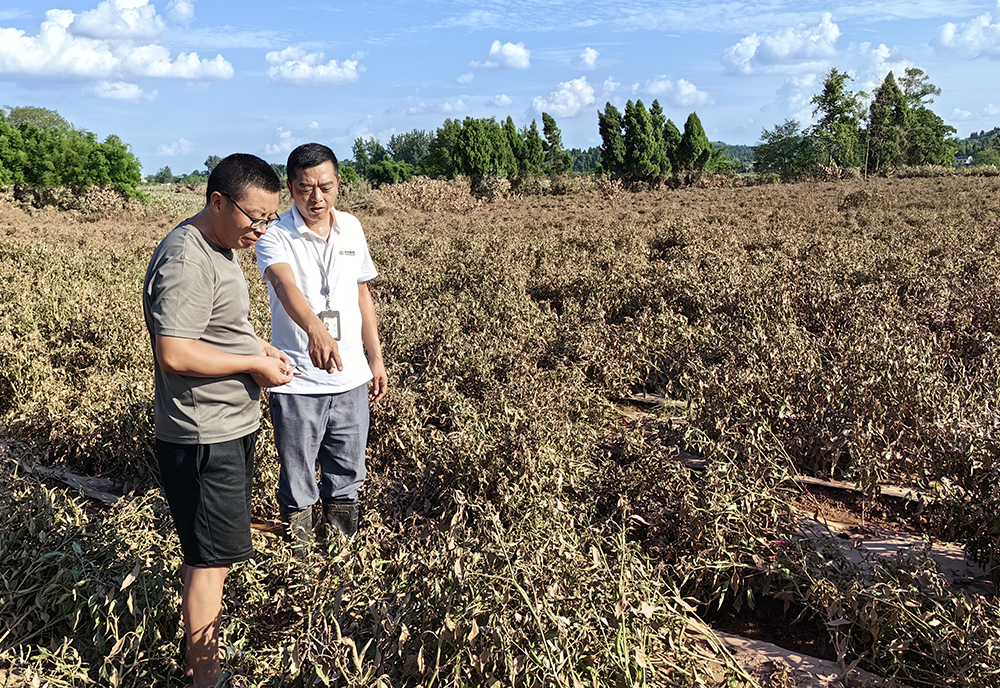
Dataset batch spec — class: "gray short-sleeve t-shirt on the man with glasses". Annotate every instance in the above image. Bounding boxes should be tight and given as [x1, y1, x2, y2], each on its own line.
[142, 224, 260, 444]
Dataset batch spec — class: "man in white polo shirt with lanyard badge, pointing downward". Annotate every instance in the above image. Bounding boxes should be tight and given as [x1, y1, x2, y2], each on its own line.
[256, 143, 388, 545]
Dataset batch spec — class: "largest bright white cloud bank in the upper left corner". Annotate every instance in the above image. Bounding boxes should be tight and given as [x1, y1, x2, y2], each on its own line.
[0, 7, 233, 81]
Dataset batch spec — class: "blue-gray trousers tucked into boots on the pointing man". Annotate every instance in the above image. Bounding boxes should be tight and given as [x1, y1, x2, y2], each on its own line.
[270, 383, 369, 513]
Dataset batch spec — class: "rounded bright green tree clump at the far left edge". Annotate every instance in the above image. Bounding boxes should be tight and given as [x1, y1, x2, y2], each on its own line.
[0, 107, 142, 196]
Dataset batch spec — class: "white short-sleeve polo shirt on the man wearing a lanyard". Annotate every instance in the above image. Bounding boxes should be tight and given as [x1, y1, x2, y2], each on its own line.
[255, 206, 378, 394]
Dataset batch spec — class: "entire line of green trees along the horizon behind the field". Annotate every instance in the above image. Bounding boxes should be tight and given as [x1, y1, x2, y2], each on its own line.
[7, 68, 1000, 204]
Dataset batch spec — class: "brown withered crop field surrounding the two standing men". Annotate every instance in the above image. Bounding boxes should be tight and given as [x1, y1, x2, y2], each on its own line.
[0, 176, 1000, 688]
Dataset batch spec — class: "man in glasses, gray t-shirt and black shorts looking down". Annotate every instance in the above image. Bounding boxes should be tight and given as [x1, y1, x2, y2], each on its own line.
[142, 154, 292, 688]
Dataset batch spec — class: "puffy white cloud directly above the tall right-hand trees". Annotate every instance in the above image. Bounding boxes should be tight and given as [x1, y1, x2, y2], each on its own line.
[722, 12, 840, 74]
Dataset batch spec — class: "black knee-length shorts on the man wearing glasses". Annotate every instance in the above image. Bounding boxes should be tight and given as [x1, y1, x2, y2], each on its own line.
[156, 432, 257, 567]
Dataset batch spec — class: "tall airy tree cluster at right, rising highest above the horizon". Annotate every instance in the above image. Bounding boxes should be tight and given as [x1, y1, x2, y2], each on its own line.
[754, 67, 957, 177]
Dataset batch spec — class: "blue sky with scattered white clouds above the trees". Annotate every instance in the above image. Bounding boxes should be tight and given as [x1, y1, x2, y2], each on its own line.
[0, 0, 1000, 174]
